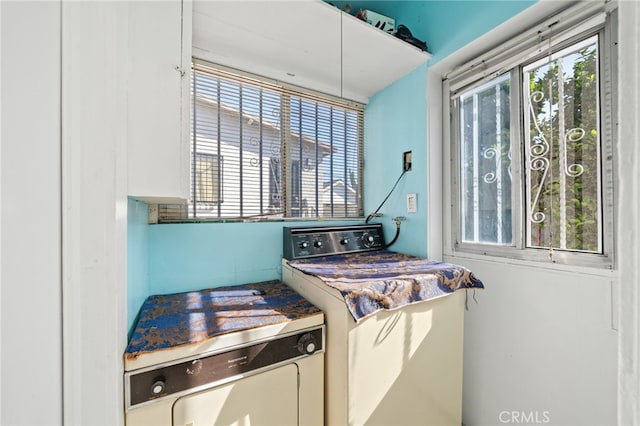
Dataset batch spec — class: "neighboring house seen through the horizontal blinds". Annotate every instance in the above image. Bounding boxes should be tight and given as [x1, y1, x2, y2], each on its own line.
[192, 94, 358, 217]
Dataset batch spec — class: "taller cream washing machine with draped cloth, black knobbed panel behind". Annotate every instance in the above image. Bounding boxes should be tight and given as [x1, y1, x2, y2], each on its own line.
[282, 225, 482, 426]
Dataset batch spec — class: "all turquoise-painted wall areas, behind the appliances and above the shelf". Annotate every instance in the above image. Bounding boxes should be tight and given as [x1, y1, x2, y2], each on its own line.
[128, 0, 533, 325]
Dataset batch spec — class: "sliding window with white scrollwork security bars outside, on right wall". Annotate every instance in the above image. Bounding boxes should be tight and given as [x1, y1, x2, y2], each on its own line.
[444, 3, 615, 267]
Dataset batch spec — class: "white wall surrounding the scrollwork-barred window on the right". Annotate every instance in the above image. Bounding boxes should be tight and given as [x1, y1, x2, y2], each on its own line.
[427, 1, 640, 426]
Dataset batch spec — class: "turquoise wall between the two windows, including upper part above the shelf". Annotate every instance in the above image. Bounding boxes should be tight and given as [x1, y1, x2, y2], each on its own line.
[360, 1, 534, 256]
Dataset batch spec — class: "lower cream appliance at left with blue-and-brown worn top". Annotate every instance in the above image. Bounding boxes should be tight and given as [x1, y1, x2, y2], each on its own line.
[124, 281, 325, 426]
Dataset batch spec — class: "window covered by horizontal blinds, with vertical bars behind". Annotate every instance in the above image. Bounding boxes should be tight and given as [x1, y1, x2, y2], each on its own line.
[187, 61, 364, 220]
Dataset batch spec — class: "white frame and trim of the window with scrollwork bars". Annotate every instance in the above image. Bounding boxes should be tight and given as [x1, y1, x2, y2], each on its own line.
[440, 1, 617, 270]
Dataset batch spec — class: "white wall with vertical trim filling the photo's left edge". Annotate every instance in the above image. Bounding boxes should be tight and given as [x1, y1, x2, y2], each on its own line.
[0, 1, 127, 425]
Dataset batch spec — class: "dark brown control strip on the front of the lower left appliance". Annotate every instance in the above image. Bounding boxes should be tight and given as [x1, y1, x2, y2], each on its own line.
[125, 326, 325, 410]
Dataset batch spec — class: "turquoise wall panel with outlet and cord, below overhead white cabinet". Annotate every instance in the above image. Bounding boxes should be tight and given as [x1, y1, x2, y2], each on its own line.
[364, 66, 427, 256]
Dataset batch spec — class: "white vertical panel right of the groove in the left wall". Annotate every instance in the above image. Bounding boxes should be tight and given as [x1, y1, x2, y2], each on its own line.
[62, 1, 128, 425]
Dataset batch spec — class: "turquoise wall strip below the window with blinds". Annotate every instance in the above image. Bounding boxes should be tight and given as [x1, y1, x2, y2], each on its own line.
[148, 221, 354, 294]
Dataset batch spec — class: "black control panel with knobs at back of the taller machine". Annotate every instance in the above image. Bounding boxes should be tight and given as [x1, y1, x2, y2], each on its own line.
[283, 223, 385, 260]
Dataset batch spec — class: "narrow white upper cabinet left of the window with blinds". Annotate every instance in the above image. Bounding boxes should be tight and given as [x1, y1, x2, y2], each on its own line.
[127, 0, 192, 203]
